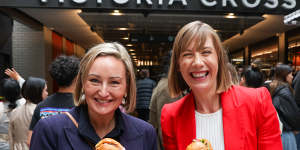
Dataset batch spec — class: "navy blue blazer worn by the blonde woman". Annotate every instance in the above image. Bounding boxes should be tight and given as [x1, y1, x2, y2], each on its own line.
[30, 107, 157, 150]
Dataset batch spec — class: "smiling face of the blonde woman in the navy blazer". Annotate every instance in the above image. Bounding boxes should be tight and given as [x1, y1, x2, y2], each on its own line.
[83, 56, 126, 116]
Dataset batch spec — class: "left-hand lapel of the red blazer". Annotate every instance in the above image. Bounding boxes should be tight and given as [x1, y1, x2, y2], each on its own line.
[175, 94, 196, 150]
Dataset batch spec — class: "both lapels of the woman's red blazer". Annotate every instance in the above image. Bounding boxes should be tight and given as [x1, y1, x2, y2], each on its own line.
[180, 86, 247, 150]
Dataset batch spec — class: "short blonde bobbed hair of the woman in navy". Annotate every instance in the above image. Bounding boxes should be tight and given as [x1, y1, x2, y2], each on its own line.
[74, 42, 136, 112]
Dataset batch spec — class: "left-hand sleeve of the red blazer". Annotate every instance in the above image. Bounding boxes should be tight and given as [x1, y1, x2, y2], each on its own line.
[161, 105, 178, 150]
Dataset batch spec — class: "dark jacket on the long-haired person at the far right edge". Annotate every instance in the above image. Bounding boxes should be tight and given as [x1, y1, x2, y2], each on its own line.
[272, 85, 300, 131]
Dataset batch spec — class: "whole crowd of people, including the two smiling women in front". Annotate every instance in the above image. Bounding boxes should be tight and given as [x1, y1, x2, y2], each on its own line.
[0, 21, 300, 150]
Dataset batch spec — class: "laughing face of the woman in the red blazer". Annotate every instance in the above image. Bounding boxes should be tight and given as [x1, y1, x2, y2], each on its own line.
[178, 37, 218, 91]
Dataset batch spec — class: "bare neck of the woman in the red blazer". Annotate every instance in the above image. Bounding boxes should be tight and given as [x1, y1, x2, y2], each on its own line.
[193, 88, 221, 114]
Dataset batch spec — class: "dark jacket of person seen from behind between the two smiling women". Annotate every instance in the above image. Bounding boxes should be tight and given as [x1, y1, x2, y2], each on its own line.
[136, 78, 156, 109]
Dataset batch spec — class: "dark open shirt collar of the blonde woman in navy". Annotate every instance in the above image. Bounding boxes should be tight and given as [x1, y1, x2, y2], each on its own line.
[78, 105, 125, 144]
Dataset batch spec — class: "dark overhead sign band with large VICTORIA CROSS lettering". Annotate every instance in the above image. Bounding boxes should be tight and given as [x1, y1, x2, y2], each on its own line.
[0, 0, 300, 14]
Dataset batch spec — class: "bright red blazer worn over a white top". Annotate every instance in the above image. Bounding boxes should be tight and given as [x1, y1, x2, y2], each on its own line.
[161, 86, 282, 150]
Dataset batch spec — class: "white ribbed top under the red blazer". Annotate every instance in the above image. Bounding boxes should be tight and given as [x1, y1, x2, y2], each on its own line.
[195, 109, 224, 150]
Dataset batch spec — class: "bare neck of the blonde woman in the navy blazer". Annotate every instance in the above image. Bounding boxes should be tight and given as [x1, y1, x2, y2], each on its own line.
[89, 111, 115, 139]
